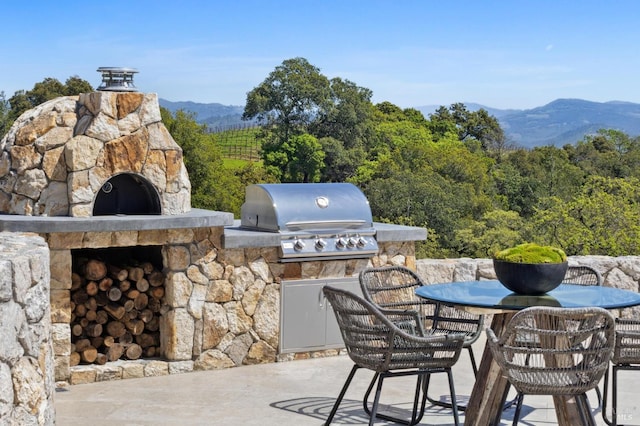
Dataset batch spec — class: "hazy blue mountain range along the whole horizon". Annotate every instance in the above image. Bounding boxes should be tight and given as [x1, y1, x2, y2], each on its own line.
[159, 99, 640, 148]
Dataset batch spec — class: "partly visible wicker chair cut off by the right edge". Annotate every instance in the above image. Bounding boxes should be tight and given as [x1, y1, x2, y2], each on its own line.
[602, 318, 640, 426]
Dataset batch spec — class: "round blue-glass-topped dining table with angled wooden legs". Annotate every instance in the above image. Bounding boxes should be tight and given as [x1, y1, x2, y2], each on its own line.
[416, 280, 640, 426]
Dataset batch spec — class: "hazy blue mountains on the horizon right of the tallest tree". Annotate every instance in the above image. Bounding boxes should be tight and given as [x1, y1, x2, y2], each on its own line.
[416, 99, 640, 148]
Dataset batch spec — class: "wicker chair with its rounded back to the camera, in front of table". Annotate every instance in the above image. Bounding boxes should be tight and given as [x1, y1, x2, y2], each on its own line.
[487, 306, 615, 425]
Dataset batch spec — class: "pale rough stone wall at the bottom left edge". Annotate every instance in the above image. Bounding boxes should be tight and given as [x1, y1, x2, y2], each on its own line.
[0, 232, 55, 425]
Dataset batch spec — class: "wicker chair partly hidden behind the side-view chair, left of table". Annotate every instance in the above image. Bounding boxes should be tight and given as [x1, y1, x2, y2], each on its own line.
[359, 266, 484, 410]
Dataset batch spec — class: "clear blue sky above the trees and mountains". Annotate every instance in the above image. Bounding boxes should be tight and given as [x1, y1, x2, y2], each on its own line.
[5, 0, 640, 109]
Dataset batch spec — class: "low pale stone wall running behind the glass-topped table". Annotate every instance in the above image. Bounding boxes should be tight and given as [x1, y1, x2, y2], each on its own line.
[416, 256, 640, 317]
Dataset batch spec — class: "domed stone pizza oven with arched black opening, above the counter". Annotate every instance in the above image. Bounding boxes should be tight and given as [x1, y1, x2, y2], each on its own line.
[0, 91, 191, 217]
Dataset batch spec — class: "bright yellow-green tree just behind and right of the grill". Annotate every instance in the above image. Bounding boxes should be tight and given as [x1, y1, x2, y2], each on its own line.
[353, 121, 493, 255]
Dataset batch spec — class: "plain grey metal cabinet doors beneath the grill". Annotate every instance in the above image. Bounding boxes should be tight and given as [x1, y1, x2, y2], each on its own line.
[279, 277, 362, 353]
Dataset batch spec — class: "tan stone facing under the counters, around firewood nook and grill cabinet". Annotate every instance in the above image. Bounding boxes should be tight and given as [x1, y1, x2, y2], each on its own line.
[50, 227, 415, 386]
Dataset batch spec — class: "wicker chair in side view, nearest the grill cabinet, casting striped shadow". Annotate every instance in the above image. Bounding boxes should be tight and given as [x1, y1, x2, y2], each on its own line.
[323, 286, 463, 425]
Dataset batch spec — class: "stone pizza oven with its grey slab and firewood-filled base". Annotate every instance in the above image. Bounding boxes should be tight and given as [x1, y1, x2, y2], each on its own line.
[0, 75, 245, 383]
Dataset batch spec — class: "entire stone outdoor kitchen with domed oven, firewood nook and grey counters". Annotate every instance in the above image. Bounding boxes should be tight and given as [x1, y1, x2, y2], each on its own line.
[0, 69, 426, 384]
